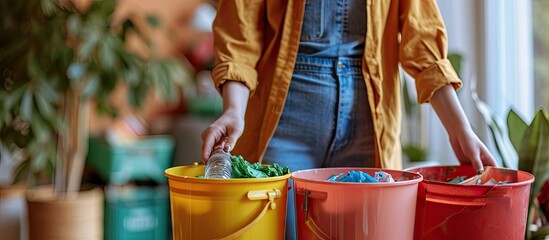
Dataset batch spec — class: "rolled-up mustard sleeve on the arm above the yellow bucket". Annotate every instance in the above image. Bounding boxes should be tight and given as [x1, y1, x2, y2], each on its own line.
[212, 0, 265, 94]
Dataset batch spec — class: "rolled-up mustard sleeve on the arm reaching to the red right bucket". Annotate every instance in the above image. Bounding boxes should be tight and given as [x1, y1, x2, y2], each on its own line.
[399, 0, 462, 103]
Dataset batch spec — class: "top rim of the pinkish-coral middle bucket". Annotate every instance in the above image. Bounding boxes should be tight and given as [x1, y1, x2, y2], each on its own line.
[291, 167, 423, 187]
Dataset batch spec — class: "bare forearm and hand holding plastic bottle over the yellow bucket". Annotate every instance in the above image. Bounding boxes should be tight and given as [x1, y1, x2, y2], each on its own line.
[202, 81, 250, 162]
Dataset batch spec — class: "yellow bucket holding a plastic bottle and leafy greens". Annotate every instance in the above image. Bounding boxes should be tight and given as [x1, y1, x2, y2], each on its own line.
[164, 165, 291, 240]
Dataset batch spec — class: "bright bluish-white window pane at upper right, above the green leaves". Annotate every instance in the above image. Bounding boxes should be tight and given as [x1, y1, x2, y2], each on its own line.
[484, 0, 538, 118]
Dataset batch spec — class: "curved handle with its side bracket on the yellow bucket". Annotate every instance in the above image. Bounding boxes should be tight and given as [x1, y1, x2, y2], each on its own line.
[218, 189, 282, 240]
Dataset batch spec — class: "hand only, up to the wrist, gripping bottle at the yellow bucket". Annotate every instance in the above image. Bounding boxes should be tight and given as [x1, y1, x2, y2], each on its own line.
[202, 111, 244, 163]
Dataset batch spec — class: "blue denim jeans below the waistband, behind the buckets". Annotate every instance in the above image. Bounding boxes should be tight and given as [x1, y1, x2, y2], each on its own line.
[263, 55, 375, 240]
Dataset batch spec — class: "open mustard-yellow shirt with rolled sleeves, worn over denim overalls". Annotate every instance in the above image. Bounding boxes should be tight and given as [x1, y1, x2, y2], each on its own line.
[212, 0, 461, 169]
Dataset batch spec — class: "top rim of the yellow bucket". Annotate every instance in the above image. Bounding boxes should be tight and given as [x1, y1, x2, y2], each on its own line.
[164, 165, 291, 184]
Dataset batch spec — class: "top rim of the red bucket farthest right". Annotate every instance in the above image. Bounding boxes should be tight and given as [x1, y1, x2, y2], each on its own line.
[404, 165, 536, 188]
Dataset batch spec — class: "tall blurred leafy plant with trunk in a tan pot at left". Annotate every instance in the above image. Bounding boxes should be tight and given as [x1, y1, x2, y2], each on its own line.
[0, 0, 186, 239]
